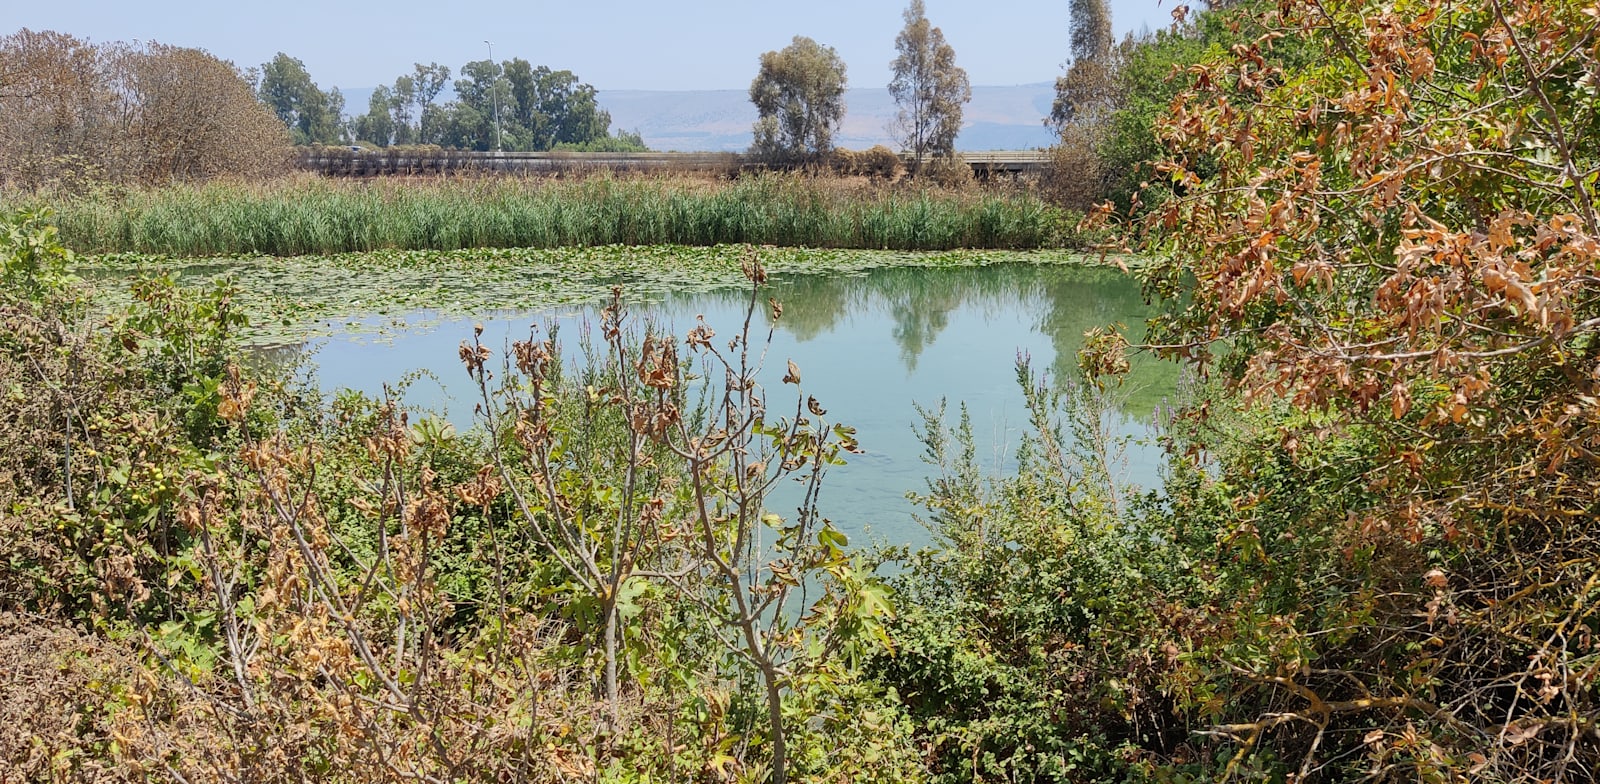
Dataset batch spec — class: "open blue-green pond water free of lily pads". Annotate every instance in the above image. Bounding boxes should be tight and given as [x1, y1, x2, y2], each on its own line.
[306, 264, 1178, 546]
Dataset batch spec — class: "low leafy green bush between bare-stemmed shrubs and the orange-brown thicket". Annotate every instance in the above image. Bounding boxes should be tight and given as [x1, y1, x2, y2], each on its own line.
[870, 366, 1197, 782]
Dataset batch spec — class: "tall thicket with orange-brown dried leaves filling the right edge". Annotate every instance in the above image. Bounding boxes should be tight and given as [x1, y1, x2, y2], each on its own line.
[1147, 0, 1600, 781]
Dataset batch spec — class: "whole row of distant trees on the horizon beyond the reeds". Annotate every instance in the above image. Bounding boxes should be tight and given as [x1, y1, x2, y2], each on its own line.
[0, 0, 1190, 191]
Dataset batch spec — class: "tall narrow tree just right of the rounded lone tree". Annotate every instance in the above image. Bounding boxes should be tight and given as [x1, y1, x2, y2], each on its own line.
[890, 0, 973, 174]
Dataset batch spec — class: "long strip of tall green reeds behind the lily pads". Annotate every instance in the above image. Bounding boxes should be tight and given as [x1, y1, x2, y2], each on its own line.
[35, 174, 1075, 256]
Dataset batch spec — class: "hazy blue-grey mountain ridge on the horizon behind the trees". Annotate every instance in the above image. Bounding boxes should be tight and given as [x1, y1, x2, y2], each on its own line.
[341, 83, 1056, 152]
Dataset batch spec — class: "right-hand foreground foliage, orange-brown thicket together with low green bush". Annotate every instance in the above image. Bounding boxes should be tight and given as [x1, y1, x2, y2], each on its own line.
[875, 0, 1600, 782]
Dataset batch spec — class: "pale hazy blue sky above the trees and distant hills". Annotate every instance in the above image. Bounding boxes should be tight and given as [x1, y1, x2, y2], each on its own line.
[9, 0, 1182, 93]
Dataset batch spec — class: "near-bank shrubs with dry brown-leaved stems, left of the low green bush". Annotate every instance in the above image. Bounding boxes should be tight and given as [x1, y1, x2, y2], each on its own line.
[0, 214, 915, 782]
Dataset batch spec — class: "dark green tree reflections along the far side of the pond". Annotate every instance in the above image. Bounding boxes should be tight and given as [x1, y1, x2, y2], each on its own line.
[659, 264, 1178, 416]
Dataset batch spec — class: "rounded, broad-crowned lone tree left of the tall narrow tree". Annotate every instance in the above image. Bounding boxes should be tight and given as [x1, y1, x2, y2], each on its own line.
[750, 35, 845, 160]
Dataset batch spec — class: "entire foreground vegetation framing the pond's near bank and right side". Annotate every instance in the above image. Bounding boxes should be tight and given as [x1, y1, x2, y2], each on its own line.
[0, 0, 1600, 782]
